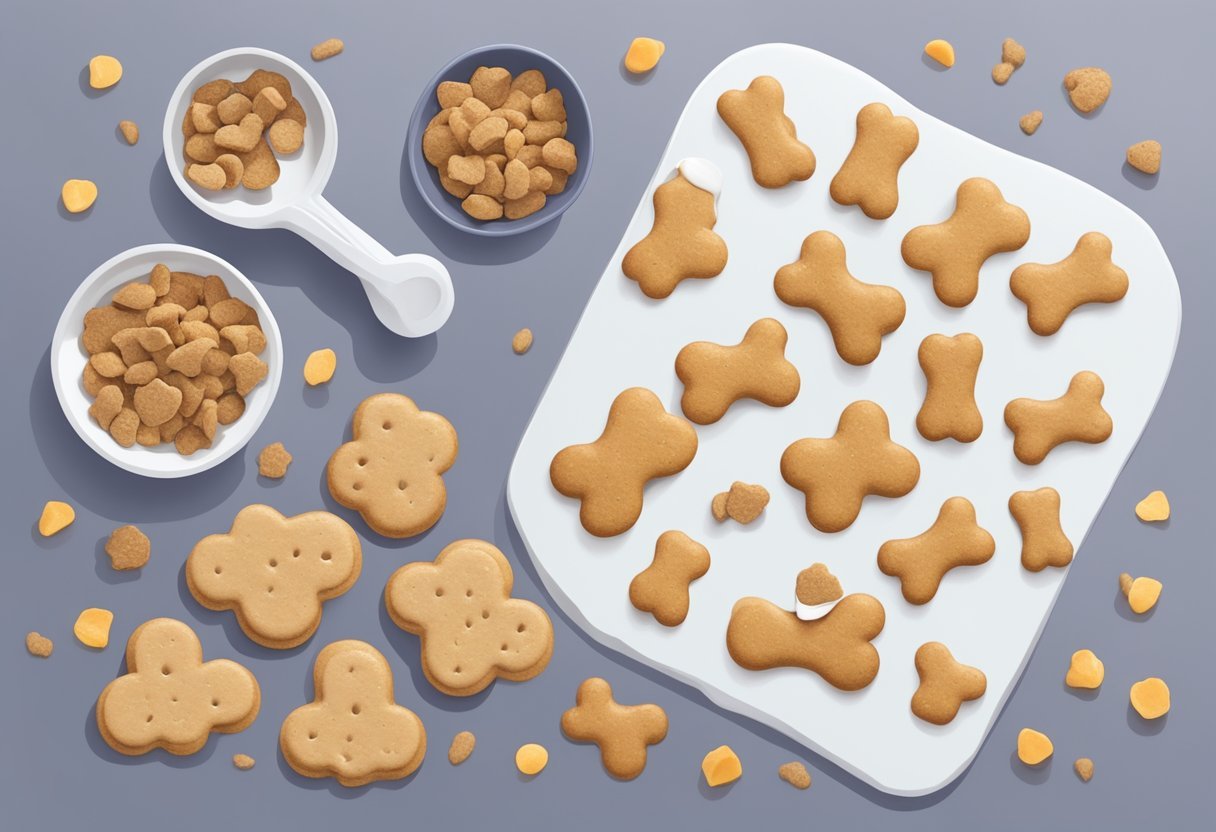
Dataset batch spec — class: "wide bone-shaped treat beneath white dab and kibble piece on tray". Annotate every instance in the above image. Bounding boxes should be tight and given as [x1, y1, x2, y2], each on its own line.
[726, 594, 886, 691]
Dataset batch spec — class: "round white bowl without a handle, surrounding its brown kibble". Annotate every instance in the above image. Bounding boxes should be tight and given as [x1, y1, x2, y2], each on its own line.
[51, 243, 283, 478]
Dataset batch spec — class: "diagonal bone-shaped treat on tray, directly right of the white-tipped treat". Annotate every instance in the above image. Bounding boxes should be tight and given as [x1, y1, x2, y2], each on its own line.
[772, 231, 905, 365]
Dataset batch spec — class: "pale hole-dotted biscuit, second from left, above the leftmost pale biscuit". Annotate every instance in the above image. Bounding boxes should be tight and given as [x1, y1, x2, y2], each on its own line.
[186, 505, 362, 650]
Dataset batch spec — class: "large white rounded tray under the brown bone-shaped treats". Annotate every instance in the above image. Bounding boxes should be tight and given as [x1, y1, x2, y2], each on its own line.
[507, 44, 1181, 796]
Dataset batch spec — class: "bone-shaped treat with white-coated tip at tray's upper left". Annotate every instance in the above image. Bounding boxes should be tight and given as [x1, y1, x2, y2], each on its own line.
[620, 159, 727, 299]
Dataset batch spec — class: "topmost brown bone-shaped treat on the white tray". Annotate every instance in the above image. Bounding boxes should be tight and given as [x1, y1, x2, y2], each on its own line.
[717, 75, 815, 187]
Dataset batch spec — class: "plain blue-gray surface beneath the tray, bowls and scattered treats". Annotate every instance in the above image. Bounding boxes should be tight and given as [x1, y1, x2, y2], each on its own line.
[0, 0, 1216, 830]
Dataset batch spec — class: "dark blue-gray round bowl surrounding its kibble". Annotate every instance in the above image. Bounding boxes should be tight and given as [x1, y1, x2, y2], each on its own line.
[406, 44, 593, 237]
